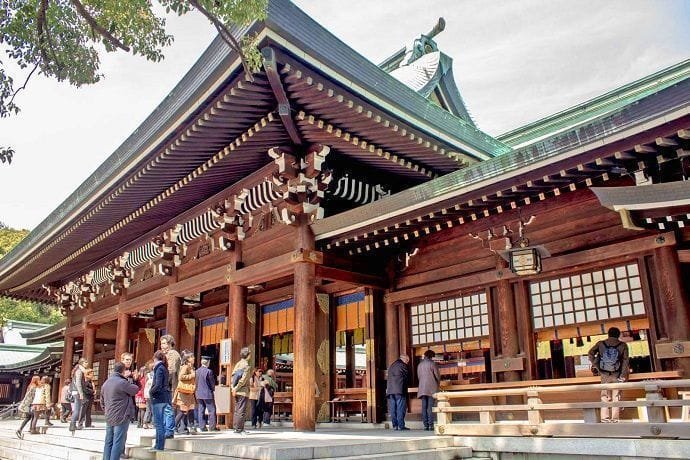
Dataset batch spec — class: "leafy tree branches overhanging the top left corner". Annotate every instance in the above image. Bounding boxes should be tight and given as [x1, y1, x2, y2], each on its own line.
[0, 0, 268, 163]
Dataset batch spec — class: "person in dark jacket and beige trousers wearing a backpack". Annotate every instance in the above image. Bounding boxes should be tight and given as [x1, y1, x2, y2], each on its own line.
[589, 327, 630, 423]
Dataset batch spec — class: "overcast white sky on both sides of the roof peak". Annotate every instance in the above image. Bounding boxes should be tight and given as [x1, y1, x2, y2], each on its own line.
[0, 0, 690, 229]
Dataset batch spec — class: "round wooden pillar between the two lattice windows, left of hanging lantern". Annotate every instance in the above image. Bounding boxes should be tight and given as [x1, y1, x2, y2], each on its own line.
[496, 257, 520, 382]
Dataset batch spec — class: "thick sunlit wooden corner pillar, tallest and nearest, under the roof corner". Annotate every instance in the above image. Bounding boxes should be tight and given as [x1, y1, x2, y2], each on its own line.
[292, 215, 316, 431]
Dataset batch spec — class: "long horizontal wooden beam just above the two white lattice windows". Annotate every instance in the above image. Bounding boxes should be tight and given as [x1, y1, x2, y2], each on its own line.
[384, 232, 676, 303]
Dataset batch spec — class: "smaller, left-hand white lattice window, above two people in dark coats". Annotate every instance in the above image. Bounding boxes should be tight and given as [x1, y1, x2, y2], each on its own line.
[411, 292, 489, 345]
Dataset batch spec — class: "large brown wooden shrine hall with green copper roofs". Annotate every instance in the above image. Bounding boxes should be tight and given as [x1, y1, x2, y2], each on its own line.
[0, 0, 690, 430]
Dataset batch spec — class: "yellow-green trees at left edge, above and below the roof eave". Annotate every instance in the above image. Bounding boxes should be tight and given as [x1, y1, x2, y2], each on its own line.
[0, 222, 62, 324]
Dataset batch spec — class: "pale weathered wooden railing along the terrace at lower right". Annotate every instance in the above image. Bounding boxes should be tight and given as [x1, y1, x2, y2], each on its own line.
[434, 380, 690, 439]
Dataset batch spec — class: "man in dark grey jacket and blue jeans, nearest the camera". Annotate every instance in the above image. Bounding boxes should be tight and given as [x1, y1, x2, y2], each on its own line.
[101, 362, 139, 460]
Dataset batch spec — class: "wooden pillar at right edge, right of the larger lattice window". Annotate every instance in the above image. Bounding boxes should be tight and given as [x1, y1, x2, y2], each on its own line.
[653, 246, 690, 375]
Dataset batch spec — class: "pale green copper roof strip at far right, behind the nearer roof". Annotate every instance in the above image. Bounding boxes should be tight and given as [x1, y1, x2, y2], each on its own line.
[497, 59, 690, 148]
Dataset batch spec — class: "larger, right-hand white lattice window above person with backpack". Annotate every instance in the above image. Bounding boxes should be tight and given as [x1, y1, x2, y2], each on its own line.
[530, 264, 645, 329]
